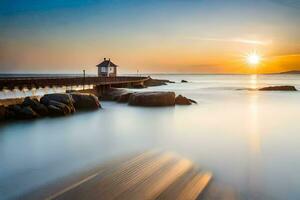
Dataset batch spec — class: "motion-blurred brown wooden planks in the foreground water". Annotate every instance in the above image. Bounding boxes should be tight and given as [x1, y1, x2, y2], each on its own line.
[34, 152, 212, 200]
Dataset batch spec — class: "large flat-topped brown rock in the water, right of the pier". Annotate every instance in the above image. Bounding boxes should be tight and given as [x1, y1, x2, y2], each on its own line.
[129, 92, 175, 106]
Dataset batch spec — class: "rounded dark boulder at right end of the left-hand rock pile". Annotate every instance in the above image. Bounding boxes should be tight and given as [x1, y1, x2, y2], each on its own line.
[71, 93, 101, 110]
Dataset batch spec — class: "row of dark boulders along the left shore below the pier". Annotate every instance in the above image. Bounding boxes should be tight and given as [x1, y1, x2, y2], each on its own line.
[0, 93, 101, 120]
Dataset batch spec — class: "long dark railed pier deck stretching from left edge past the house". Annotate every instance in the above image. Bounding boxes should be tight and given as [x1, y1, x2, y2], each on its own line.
[0, 76, 149, 90]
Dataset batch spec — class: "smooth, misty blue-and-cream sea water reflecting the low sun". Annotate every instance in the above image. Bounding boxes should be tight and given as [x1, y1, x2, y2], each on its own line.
[0, 75, 300, 199]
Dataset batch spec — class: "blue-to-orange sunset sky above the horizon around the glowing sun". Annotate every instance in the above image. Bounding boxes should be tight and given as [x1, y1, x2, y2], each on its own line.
[0, 0, 300, 73]
